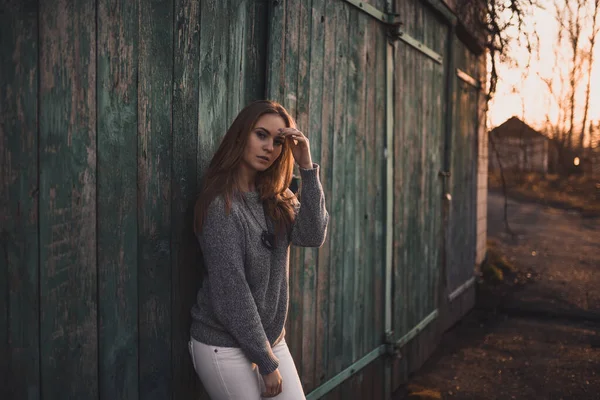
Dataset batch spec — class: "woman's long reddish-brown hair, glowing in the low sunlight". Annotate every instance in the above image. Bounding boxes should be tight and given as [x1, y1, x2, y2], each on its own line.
[194, 100, 297, 234]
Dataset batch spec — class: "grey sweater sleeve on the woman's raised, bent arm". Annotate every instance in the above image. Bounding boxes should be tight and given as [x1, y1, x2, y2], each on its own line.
[291, 163, 329, 247]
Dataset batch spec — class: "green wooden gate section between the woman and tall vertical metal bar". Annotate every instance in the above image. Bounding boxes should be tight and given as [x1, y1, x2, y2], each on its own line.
[267, 0, 386, 398]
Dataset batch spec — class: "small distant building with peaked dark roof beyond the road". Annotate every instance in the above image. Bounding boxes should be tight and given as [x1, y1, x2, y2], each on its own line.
[489, 117, 550, 173]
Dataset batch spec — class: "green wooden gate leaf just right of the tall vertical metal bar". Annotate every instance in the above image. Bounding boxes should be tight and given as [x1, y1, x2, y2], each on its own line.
[393, 0, 448, 386]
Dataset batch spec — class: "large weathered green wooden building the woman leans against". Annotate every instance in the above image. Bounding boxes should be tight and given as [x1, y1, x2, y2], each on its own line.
[0, 0, 487, 400]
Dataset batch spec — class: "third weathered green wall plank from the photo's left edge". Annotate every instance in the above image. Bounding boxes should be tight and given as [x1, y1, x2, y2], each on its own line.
[97, 0, 139, 399]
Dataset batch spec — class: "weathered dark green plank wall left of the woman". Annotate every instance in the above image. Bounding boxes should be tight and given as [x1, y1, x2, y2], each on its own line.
[0, 0, 267, 399]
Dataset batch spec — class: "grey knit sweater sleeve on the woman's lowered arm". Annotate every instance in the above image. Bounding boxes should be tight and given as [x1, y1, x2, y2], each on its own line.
[199, 199, 279, 375]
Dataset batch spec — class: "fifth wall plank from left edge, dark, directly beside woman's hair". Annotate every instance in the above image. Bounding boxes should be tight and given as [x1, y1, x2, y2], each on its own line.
[171, 0, 203, 399]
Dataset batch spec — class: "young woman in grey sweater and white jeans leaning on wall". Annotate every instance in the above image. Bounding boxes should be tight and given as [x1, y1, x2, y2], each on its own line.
[190, 101, 329, 400]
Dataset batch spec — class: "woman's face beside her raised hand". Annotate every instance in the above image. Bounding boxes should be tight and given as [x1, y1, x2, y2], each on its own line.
[242, 114, 286, 172]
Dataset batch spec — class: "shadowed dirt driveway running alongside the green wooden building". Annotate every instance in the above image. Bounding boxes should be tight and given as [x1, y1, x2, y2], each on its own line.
[394, 194, 600, 400]
